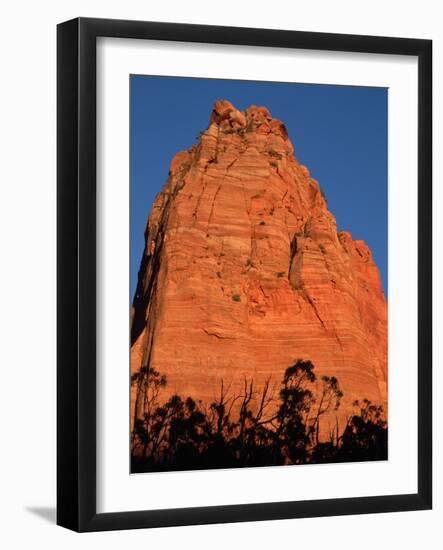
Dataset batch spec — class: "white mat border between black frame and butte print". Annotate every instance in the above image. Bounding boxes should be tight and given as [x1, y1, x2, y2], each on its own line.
[97, 39, 417, 512]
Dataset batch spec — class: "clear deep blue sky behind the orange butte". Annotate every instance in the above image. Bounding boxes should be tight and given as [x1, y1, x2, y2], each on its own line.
[130, 75, 388, 299]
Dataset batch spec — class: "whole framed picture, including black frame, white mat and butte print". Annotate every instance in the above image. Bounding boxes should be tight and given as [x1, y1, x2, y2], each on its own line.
[57, 18, 432, 531]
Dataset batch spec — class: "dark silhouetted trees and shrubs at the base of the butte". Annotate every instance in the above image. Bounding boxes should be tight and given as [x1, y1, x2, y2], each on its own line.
[131, 360, 388, 472]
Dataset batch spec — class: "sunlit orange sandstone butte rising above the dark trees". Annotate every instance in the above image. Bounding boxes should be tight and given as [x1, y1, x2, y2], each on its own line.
[131, 101, 387, 440]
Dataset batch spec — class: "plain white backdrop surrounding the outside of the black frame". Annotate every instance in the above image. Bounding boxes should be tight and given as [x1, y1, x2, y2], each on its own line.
[0, 0, 443, 549]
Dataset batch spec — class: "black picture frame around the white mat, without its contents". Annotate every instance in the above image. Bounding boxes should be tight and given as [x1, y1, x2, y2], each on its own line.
[57, 18, 432, 532]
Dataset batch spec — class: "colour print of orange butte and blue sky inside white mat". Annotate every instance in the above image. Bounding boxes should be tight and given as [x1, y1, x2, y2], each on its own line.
[128, 74, 389, 474]
